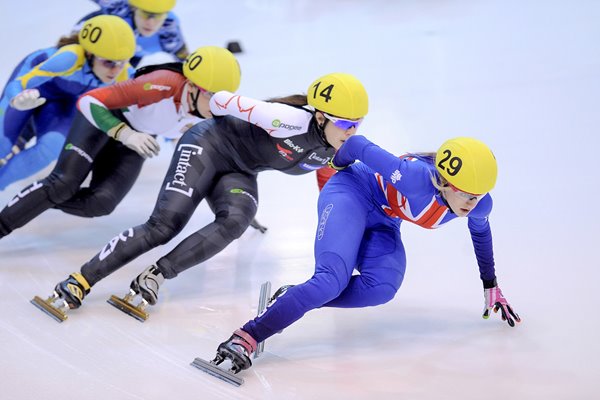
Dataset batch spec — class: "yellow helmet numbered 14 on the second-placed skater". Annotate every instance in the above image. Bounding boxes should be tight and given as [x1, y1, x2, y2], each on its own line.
[307, 73, 369, 119]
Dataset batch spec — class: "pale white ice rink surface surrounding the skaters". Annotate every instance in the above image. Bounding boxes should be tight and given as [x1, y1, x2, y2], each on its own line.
[0, 0, 600, 400]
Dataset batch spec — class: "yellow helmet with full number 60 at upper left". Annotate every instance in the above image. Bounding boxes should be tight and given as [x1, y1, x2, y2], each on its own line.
[79, 15, 136, 60]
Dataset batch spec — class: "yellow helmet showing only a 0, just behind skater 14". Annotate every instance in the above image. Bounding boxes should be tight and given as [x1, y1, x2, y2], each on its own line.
[183, 46, 242, 92]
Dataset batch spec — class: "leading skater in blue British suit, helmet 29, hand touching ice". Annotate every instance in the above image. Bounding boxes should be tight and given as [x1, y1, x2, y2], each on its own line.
[203, 136, 521, 380]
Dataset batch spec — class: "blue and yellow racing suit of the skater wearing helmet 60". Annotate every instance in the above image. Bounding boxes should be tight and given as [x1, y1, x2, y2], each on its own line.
[0, 44, 133, 190]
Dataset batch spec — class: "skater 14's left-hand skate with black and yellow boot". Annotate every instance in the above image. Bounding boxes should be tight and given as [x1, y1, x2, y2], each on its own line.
[31, 273, 90, 322]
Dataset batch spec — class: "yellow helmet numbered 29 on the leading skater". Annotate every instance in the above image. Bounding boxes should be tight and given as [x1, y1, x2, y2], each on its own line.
[435, 137, 498, 195]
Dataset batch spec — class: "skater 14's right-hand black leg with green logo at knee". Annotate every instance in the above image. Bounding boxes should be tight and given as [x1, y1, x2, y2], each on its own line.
[156, 173, 258, 279]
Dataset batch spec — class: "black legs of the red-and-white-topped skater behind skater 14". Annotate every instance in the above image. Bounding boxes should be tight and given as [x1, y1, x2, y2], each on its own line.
[0, 111, 144, 238]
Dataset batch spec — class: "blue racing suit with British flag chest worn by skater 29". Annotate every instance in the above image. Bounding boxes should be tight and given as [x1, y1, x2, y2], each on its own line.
[242, 136, 495, 342]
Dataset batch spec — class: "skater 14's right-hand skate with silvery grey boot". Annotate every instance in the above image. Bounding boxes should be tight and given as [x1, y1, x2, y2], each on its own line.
[107, 265, 165, 322]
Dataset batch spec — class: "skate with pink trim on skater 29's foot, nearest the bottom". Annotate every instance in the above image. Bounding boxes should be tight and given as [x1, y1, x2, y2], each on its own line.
[192, 329, 257, 386]
